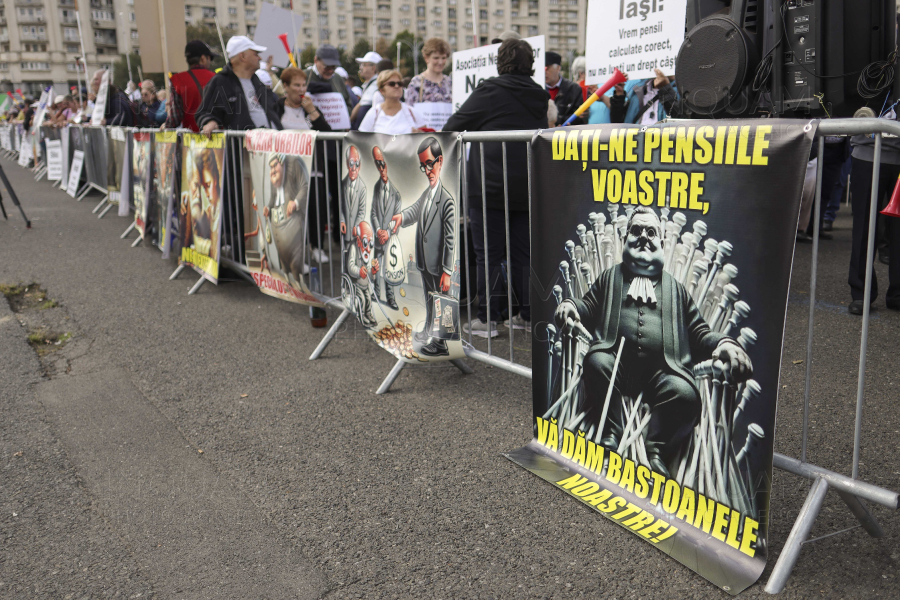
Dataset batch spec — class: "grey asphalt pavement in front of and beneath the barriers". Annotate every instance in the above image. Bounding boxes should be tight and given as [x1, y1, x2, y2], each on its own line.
[0, 159, 900, 599]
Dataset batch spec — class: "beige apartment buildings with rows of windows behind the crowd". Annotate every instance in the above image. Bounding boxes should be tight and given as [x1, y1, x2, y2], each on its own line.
[0, 0, 587, 95]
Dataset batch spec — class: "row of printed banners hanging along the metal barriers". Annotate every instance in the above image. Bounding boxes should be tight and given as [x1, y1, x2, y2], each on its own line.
[12, 120, 814, 594]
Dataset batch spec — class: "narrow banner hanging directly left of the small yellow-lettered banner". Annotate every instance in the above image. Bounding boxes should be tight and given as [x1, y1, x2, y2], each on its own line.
[153, 131, 181, 258]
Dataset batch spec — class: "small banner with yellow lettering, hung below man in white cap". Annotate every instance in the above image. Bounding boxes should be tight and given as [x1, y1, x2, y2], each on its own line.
[178, 133, 226, 283]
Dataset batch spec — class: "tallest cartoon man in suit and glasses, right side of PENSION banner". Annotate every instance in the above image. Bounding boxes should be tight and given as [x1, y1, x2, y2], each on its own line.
[391, 137, 457, 356]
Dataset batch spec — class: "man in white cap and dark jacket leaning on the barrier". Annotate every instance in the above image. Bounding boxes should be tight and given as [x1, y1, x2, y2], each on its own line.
[197, 35, 282, 134]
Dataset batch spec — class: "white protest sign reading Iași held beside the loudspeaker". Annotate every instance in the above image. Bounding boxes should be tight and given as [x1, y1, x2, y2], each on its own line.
[585, 0, 687, 84]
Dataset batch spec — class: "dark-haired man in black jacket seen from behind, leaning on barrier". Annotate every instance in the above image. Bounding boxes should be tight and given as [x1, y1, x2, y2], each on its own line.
[444, 39, 548, 337]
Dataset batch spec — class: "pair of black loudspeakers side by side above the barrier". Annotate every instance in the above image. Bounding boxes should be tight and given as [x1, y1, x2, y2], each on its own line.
[675, 0, 900, 117]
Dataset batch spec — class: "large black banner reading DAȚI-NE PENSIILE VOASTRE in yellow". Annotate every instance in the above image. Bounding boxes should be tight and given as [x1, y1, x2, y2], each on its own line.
[508, 119, 814, 594]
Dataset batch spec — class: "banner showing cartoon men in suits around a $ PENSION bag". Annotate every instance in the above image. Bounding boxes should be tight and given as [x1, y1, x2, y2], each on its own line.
[339, 132, 464, 362]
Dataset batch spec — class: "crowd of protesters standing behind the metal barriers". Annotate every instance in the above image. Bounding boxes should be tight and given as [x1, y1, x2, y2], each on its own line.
[3, 31, 900, 326]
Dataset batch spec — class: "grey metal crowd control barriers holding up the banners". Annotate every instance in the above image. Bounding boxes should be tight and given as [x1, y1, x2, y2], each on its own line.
[13, 119, 900, 594]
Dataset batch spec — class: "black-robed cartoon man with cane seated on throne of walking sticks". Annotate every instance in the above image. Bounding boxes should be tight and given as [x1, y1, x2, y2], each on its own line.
[556, 207, 752, 475]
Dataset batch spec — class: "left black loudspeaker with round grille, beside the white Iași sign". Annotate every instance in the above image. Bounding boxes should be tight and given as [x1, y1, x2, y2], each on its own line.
[675, 0, 765, 116]
